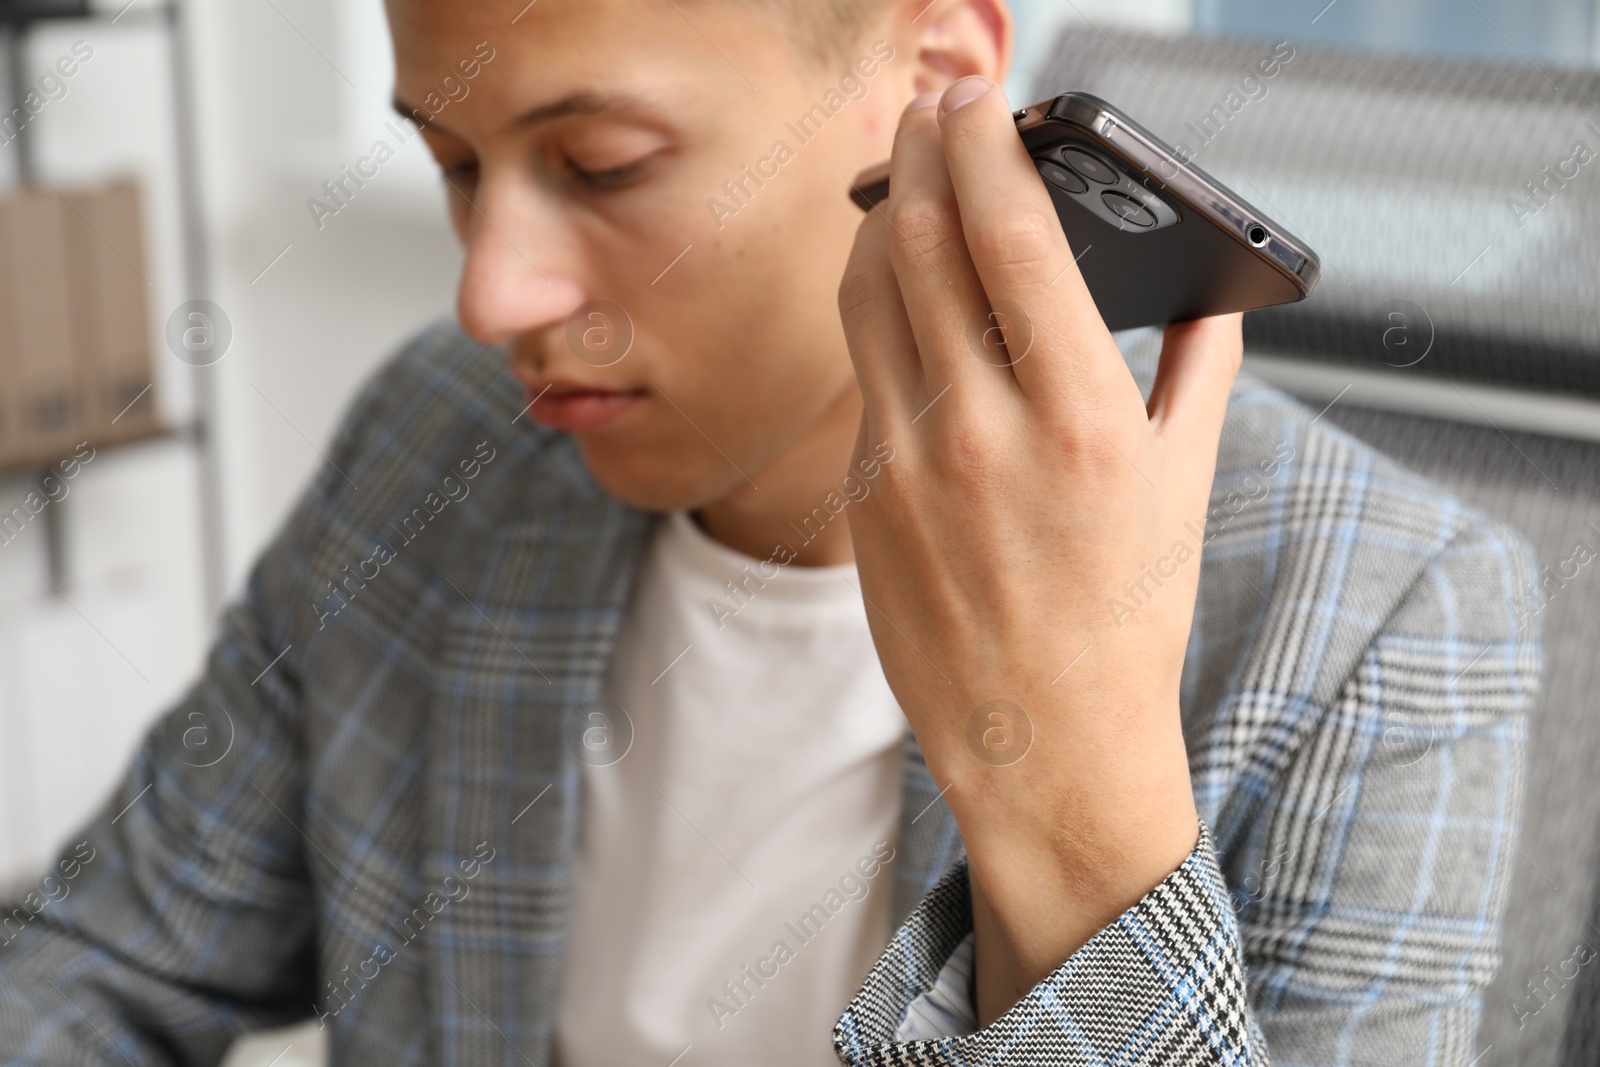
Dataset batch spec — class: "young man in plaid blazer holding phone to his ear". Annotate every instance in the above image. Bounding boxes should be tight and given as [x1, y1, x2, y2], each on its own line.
[0, 0, 1538, 1064]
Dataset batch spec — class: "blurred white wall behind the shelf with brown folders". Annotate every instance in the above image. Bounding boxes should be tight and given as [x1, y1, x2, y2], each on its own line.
[0, 0, 459, 886]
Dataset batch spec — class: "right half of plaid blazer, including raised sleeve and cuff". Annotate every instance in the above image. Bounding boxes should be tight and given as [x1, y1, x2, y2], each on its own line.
[834, 334, 1539, 1067]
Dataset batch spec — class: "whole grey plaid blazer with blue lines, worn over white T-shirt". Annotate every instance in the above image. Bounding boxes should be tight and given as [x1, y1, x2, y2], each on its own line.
[0, 325, 1539, 1067]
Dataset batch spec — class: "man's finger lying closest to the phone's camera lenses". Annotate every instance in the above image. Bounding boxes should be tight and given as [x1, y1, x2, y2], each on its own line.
[939, 77, 1142, 408]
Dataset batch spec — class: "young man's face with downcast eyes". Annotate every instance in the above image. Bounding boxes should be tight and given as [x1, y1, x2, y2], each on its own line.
[389, 0, 912, 509]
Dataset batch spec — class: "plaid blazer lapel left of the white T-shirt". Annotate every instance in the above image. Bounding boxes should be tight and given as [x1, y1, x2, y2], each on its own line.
[422, 438, 656, 1067]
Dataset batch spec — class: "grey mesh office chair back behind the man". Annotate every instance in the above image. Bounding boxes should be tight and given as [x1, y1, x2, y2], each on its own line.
[1036, 27, 1600, 1067]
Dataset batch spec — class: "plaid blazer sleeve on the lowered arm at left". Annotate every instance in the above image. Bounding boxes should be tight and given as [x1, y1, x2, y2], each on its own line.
[0, 356, 400, 1067]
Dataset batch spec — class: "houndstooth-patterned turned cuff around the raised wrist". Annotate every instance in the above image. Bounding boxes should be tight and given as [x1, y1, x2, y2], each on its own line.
[834, 822, 1267, 1067]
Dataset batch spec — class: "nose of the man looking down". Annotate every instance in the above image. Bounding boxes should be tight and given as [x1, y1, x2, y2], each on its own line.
[456, 182, 584, 344]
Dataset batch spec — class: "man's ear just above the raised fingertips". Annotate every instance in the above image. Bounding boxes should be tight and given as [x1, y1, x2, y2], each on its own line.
[894, 0, 1013, 93]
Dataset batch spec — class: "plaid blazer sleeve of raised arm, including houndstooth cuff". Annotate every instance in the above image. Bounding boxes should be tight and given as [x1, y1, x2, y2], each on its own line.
[834, 511, 1539, 1067]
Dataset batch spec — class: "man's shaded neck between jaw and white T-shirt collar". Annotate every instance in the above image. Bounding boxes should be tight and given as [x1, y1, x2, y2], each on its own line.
[694, 381, 861, 566]
